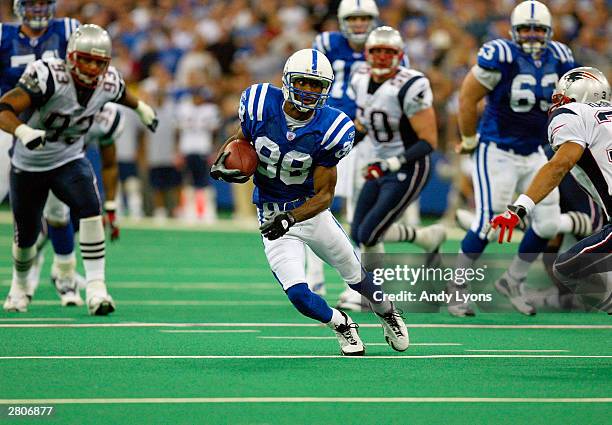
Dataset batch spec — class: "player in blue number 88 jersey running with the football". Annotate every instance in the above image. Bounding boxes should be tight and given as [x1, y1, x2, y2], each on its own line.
[211, 49, 409, 356]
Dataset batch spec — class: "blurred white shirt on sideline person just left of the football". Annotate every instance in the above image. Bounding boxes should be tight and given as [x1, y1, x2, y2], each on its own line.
[176, 101, 221, 155]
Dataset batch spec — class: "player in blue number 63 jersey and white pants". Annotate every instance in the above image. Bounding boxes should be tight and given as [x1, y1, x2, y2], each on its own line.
[448, 0, 574, 316]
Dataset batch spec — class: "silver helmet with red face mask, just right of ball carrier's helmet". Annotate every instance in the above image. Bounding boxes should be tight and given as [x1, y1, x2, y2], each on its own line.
[365, 26, 404, 77]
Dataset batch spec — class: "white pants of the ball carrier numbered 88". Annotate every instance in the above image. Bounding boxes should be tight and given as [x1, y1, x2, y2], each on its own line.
[258, 208, 363, 291]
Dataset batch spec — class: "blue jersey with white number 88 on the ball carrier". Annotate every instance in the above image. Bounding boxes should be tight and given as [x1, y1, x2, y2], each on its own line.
[238, 83, 355, 206]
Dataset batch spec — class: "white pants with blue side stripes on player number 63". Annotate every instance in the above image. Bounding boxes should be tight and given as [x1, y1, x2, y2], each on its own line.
[471, 142, 561, 240]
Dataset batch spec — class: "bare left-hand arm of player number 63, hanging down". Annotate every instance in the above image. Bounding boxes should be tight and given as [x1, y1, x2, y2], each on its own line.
[456, 71, 489, 153]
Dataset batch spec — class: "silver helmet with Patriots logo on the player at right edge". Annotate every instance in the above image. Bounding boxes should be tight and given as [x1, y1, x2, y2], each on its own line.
[552, 66, 610, 109]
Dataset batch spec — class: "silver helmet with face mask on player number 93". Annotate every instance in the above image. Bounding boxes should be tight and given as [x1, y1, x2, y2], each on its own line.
[66, 24, 112, 88]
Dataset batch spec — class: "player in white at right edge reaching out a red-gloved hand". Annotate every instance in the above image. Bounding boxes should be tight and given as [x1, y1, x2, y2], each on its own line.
[491, 67, 612, 313]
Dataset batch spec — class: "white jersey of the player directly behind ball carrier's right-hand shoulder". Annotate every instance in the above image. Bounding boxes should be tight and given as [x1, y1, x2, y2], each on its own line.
[351, 67, 433, 159]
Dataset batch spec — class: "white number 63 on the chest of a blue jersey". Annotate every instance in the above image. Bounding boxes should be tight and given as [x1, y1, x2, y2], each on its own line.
[510, 74, 559, 112]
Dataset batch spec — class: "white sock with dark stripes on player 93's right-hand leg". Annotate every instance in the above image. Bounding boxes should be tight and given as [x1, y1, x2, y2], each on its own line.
[79, 215, 105, 284]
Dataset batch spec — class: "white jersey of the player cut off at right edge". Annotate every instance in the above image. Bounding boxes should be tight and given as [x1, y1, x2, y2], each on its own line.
[548, 101, 612, 219]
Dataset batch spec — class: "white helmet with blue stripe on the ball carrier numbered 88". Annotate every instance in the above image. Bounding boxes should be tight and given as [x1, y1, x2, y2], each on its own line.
[283, 49, 334, 112]
